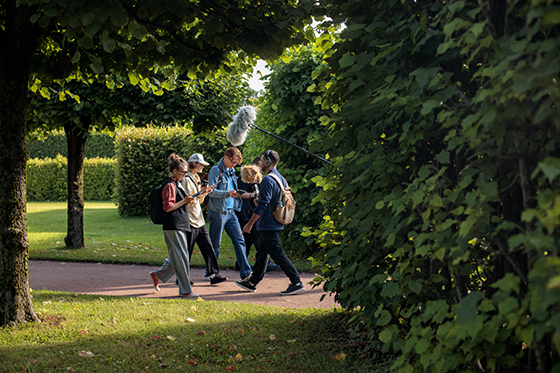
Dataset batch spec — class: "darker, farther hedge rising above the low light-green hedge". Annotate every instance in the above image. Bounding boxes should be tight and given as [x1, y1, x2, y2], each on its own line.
[27, 130, 115, 158]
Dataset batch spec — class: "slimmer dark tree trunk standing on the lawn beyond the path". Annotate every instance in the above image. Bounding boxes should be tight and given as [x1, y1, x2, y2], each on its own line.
[64, 118, 91, 248]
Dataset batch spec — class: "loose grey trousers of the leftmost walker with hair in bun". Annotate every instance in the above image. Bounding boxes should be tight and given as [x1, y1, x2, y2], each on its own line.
[154, 231, 192, 294]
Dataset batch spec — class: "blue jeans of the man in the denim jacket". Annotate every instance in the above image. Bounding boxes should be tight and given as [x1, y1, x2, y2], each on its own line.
[208, 209, 251, 279]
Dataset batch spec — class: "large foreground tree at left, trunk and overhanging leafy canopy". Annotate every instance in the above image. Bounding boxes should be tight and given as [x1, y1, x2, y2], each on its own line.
[0, 0, 312, 326]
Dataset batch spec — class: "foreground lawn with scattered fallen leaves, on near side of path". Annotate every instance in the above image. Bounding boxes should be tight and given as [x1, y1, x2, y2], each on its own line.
[0, 291, 392, 373]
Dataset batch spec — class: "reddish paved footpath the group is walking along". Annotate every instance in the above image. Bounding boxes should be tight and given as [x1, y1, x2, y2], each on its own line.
[29, 260, 338, 308]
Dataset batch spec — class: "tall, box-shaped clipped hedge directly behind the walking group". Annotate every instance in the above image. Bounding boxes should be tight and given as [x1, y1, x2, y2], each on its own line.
[115, 126, 228, 216]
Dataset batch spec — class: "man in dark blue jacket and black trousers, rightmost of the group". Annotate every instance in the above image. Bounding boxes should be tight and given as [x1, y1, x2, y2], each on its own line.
[235, 150, 305, 295]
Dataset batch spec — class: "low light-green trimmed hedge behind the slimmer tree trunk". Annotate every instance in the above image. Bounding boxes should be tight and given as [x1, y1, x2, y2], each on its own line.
[27, 155, 117, 201]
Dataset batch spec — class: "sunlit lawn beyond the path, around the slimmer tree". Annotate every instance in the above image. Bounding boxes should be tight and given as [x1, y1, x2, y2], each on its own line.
[27, 202, 311, 271]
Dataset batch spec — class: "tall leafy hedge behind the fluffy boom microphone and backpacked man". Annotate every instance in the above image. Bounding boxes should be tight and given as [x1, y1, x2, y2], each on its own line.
[244, 48, 330, 258]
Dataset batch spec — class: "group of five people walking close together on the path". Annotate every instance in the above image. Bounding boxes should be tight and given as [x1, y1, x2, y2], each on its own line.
[150, 147, 305, 298]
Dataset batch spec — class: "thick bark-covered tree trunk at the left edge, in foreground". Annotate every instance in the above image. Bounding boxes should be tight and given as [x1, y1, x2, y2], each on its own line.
[0, 0, 40, 326]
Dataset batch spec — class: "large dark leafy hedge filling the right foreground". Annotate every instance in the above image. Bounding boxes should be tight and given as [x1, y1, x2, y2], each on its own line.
[308, 0, 560, 372]
